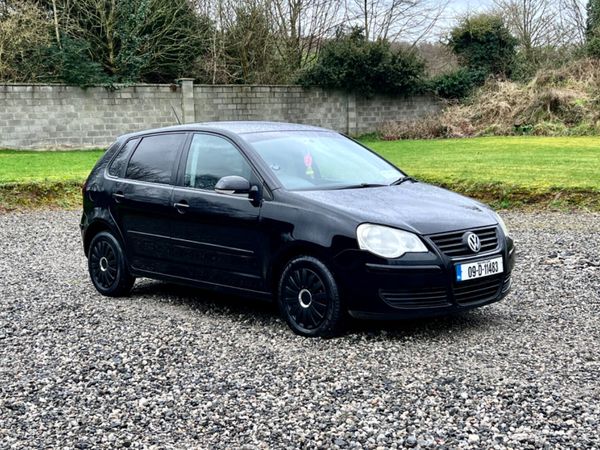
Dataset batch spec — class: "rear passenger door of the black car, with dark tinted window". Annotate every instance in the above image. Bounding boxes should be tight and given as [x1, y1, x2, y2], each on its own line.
[109, 133, 187, 274]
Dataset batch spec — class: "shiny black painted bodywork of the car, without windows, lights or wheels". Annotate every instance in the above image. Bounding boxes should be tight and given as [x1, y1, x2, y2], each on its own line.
[81, 123, 514, 318]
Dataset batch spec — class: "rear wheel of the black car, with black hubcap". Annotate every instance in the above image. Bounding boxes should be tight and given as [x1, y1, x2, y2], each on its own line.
[88, 231, 135, 297]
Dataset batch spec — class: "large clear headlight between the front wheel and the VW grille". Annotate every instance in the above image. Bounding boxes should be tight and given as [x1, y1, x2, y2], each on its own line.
[356, 223, 428, 258]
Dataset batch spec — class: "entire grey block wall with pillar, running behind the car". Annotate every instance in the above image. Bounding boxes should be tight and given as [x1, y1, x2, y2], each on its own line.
[0, 79, 439, 149]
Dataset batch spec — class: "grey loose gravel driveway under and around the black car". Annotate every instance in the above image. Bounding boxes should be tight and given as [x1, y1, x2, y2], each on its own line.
[0, 211, 600, 449]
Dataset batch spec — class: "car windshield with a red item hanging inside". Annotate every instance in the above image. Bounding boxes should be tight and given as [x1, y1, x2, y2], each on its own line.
[244, 131, 405, 191]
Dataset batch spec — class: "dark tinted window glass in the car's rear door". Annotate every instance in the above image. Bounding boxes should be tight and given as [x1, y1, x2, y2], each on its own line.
[125, 134, 185, 184]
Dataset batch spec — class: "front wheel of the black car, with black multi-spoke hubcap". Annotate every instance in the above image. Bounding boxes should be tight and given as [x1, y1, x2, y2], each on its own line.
[277, 256, 346, 337]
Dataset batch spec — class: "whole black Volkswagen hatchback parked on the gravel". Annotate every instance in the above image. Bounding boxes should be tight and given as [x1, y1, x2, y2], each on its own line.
[81, 122, 515, 336]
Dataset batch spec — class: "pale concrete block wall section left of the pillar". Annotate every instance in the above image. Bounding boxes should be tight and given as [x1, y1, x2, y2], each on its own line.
[0, 84, 182, 148]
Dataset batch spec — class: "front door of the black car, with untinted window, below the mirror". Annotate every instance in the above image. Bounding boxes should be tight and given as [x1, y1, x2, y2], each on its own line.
[166, 133, 266, 292]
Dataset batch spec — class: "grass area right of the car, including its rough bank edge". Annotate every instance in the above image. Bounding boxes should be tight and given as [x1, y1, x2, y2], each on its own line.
[363, 137, 600, 211]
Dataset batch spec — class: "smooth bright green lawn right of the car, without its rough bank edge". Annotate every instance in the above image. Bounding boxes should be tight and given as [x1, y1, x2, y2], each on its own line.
[365, 136, 600, 191]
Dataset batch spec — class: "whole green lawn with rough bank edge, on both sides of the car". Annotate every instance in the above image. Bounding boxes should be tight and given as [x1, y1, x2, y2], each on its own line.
[0, 137, 600, 210]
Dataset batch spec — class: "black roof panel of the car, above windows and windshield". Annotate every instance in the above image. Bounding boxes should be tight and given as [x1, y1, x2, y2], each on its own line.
[119, 120, 332, 139]
